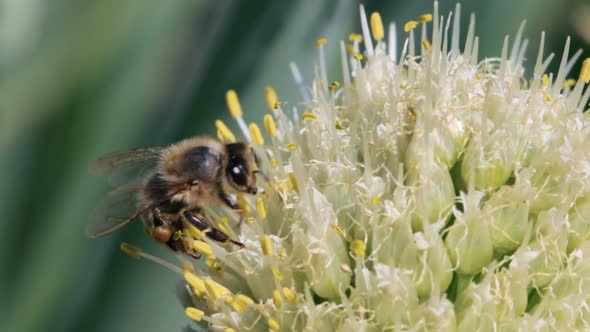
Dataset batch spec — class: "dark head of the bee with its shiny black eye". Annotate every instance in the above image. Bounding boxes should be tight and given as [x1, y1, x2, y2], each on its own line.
[225, 142, 257, 194]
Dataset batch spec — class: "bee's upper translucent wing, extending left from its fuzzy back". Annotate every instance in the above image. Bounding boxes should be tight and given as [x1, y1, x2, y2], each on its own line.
[90, 147, 164, 186]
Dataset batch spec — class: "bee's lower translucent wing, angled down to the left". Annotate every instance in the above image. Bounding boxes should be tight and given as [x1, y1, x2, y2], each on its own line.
[86, 185, 186, 238]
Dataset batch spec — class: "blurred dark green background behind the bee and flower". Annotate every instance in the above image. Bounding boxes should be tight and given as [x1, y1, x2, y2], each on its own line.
[0, 0, 590, 331]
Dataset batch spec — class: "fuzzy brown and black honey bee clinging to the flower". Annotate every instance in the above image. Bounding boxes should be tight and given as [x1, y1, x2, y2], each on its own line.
[87, 136, 259, 258]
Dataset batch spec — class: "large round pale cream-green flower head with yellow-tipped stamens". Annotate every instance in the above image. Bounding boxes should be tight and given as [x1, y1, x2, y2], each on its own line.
[128, 2, 590, 331]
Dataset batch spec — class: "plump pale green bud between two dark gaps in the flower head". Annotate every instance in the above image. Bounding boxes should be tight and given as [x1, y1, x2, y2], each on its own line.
[445, 192, 494, 274]
